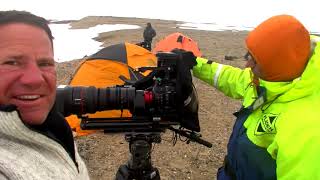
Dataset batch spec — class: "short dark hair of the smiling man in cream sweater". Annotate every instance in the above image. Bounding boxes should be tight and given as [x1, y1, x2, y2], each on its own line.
[0, 10, 53, 44]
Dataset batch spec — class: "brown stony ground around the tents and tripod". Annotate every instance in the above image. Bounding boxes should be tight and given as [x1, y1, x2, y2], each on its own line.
[57, 17, 248, 180]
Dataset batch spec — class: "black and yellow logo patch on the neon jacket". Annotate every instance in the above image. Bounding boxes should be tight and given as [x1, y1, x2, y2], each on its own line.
[254, 114, 278, 135]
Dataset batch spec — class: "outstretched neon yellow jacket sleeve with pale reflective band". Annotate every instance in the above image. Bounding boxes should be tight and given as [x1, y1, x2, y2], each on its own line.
[193, 57, 251, 99]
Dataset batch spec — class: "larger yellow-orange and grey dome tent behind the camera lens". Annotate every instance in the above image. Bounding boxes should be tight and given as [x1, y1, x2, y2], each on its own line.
[66, 43, 157, 136]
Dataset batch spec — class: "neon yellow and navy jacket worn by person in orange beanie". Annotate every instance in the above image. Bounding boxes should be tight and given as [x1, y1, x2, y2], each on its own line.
[193, 36, 320, 179]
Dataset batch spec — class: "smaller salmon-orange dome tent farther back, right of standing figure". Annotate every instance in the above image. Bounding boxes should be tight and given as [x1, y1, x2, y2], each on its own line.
[152, 32, 202, 57]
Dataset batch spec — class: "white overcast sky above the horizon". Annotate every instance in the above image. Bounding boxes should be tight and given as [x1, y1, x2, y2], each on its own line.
[0, 0, 320, 32]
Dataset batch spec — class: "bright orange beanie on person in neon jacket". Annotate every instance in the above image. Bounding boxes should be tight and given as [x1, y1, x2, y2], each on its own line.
[246, 15, 310, 81]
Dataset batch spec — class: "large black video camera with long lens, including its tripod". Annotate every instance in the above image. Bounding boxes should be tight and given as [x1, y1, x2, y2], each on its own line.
[56, 52, 212, 179]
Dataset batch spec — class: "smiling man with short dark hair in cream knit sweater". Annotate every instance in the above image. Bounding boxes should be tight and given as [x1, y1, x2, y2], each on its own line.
[0, 11, 89, 180]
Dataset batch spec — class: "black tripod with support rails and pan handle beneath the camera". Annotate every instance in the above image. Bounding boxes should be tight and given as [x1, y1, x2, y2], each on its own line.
[81, 117, 212, 180]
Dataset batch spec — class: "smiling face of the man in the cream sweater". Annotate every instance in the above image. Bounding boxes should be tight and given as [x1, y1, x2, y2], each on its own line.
[0, 23, 56, 124]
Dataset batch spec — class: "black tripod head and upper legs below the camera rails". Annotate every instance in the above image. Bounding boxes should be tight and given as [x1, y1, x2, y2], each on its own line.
[115, 133, 161, 180]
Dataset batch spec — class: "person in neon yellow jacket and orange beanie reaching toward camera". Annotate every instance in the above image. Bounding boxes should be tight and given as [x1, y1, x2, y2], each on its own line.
[193, 15, 320, 180]
